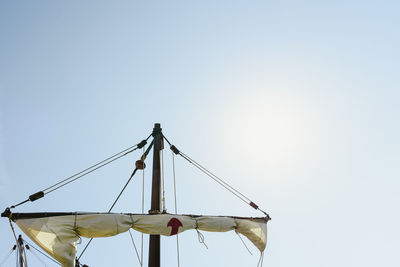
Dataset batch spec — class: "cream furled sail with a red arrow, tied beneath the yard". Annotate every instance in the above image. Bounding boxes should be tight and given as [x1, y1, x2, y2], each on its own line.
[11, 213, 269, 267]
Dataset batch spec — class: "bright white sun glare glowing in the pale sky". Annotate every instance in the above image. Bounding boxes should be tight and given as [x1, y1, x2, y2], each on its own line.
[225, 93, 310, 171]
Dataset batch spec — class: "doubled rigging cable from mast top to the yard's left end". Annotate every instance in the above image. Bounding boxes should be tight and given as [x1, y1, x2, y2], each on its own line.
[10, 135, 151, 208]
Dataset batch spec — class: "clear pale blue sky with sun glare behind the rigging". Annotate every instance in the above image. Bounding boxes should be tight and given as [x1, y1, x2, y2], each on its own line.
[0, 0, 400, 267]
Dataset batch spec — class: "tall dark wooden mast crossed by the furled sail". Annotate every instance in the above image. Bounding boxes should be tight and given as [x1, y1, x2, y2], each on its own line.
[149, 123, 164, 267]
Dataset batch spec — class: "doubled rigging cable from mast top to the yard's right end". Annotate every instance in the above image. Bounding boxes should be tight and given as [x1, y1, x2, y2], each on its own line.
[163, 136, 269, 218]
